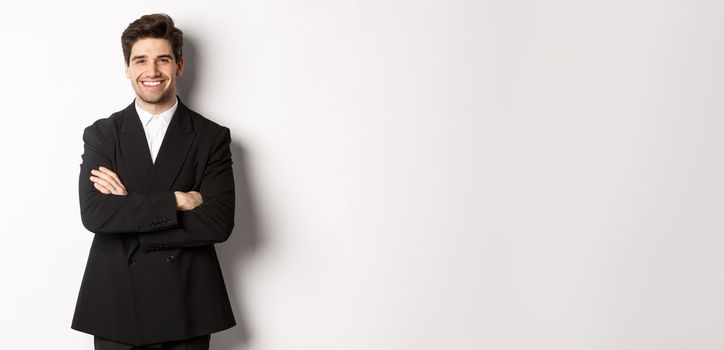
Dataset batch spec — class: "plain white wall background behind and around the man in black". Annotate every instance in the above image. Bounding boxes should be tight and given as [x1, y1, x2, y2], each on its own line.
[0, 0, 724, 350]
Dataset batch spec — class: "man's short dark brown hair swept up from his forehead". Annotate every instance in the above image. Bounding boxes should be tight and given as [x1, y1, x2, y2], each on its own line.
[121, 13, 184, 65]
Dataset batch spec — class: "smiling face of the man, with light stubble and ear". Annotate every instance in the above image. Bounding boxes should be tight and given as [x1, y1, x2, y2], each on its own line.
[126, 38, 184, 114]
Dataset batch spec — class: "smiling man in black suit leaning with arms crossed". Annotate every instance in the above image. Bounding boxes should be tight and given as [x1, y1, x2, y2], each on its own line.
[71, 14, 235, 350]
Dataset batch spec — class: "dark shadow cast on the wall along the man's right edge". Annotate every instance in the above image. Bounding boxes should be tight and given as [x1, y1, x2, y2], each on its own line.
[177, 33, 260, 350]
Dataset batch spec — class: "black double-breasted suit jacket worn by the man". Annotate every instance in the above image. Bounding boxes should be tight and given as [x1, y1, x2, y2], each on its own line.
[71, 101, 235, 345]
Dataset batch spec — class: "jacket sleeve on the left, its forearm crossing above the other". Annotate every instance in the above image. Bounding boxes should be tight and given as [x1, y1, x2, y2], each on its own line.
[78, 123, 179, 234]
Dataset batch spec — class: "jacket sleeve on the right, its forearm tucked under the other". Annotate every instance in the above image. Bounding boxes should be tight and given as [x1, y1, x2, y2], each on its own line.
[139, 128, 235, 250]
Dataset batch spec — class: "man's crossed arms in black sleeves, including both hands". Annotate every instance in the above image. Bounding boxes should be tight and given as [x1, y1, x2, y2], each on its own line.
[79, 124, 235, 250]
